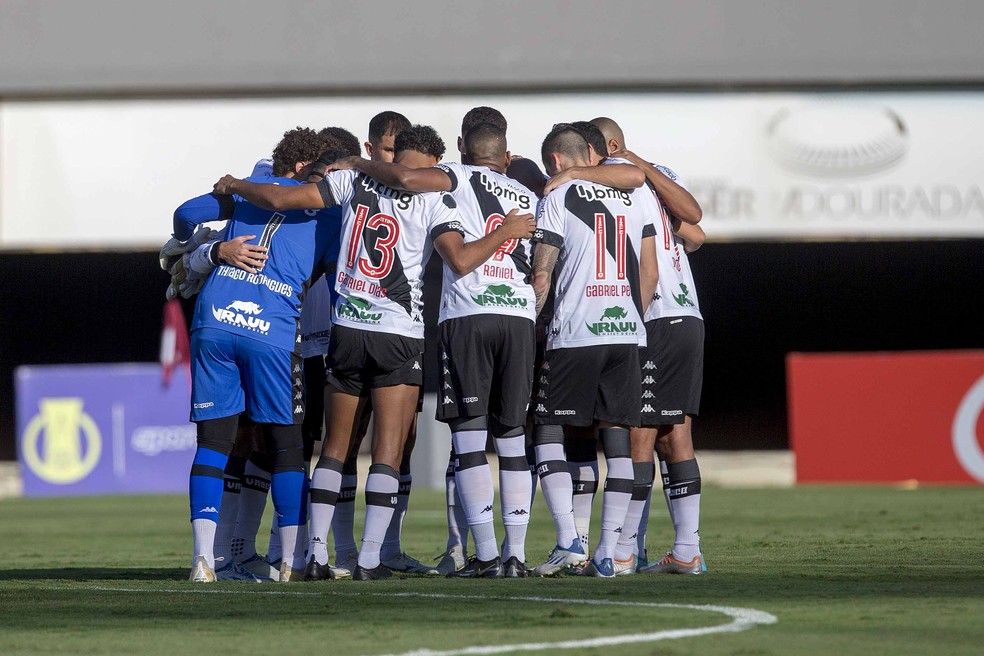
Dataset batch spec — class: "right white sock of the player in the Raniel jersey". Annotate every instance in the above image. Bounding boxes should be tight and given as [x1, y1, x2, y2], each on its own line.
[495, 435, 533, 563]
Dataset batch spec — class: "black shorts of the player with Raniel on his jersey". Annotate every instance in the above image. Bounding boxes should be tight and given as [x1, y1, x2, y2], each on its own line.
[437, 314, 536, 428]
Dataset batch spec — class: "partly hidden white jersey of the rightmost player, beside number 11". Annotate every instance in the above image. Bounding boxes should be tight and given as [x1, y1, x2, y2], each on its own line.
[646, 164, 703, 321]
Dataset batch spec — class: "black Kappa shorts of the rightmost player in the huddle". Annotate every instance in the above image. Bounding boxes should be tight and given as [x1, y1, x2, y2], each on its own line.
[639, 317, 704, 426]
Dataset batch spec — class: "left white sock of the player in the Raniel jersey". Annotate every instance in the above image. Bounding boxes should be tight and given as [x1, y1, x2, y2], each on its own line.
[451, 429, 499, 560]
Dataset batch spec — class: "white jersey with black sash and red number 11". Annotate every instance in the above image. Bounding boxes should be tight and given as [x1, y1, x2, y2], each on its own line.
[533, 174, 659, 349]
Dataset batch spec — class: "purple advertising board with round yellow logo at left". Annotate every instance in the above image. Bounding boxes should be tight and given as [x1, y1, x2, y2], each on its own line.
[15, 364, 196, 497]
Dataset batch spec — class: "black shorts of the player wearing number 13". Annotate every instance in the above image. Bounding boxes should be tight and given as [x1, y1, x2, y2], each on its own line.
[325, 326, 424, 396]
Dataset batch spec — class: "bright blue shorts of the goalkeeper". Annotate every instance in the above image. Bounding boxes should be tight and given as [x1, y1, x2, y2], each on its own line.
[191, 328, 304, 424]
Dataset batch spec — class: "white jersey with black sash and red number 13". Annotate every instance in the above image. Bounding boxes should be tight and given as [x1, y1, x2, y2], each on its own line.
[318, 171, 463, 339]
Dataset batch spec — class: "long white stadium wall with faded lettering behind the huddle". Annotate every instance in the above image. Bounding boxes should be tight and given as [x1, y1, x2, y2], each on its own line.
[0, 91, 984, 250]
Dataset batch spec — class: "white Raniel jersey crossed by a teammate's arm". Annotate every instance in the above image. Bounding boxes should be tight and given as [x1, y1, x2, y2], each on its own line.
[436, 163, 537, 322]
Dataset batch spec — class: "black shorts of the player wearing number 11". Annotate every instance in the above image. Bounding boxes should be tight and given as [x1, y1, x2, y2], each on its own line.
[533, 344, 641, 426]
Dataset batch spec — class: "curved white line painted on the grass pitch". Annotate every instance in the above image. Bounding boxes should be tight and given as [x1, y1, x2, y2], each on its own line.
[73, 586, 779, 656]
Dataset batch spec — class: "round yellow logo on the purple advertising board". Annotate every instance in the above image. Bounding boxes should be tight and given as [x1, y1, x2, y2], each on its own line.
[21, 398, 102, 485]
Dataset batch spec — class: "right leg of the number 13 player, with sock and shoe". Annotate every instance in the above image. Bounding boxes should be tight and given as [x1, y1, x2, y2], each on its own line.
[353, 384, 420, 580]
